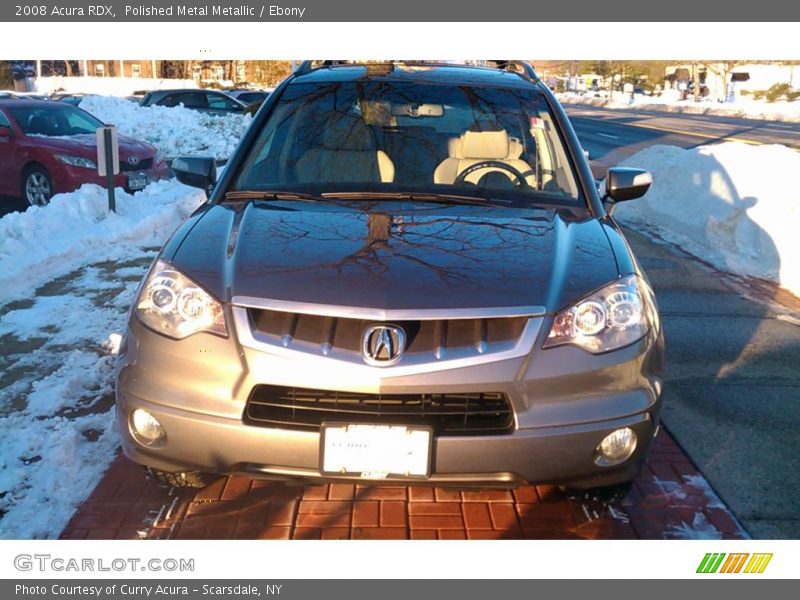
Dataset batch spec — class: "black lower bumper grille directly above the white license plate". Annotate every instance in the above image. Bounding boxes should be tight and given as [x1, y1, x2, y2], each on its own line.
[244, 385, 514, 436]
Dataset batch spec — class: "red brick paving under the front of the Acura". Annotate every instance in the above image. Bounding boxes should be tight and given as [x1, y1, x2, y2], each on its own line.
[61, 430, 747, 539]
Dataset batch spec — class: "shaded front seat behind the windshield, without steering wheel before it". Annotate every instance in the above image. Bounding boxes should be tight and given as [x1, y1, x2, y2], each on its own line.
[295, 115, 394, 183]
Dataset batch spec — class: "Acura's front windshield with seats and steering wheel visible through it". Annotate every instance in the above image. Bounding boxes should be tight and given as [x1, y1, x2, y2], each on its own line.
[233, 81, 579, 204]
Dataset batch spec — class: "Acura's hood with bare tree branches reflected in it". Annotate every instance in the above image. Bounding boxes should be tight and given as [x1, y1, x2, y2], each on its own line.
[164, 201, 619, 311]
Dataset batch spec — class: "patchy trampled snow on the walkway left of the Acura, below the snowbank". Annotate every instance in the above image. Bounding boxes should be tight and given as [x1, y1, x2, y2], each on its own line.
[0, 268, 144, 539]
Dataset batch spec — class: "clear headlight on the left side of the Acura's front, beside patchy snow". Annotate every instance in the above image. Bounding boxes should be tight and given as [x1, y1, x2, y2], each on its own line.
[135, 260, 228, 339]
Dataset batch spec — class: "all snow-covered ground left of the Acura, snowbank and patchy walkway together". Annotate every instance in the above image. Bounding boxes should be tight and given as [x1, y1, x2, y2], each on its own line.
[0, 181, 204, 538]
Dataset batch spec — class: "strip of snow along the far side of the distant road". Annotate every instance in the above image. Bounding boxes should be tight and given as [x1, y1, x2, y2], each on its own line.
[557, 92, 800, 123]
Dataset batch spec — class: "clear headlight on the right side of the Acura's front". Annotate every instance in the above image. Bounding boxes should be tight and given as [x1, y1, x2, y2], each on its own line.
[544, 275, 654, 353]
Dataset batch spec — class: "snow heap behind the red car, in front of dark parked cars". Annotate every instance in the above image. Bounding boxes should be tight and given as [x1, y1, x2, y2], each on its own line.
[80, 96, 252, 159]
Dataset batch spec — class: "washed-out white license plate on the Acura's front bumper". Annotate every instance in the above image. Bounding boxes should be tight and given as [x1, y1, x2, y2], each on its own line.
[320, 423, 433, 479]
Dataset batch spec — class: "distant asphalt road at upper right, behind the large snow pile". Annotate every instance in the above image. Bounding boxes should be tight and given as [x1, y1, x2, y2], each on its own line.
[564, 104, 800, 177]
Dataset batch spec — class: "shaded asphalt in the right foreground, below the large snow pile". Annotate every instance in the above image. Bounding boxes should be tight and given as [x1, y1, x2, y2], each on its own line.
[627, 231, 800, 539]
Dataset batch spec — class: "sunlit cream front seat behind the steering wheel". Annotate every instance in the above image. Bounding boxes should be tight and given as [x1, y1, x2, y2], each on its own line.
[433, 130, 536, 186]
